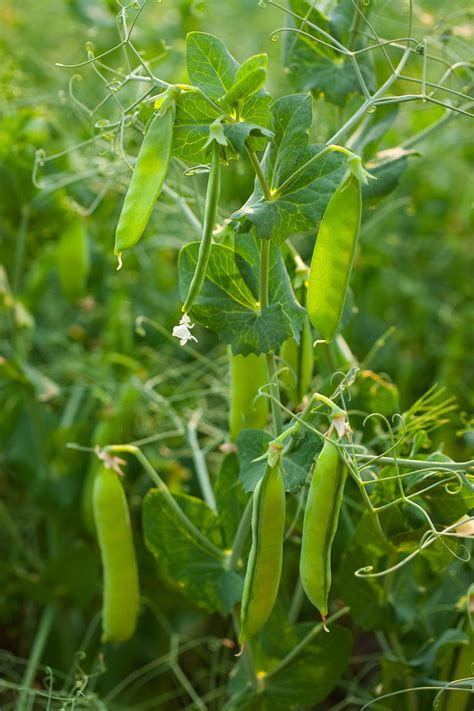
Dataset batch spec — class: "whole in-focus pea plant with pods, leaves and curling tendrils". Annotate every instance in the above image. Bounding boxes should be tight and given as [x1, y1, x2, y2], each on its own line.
[34, 0, 474, 710]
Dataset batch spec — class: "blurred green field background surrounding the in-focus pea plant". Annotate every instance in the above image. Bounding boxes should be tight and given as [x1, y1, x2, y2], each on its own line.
[0, 0, 474, 709]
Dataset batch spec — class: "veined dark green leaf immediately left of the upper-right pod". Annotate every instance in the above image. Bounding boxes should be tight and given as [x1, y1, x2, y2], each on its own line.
[232, 94, 344, 244]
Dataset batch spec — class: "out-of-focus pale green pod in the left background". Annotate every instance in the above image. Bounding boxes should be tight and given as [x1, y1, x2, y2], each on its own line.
[56, 220, 90, 302]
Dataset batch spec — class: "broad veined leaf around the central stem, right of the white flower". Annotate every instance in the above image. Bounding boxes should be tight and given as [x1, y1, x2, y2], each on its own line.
[179, 235, 304, 355]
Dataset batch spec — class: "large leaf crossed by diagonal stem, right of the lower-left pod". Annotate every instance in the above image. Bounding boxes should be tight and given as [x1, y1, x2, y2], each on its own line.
[143, 489, 243, 615]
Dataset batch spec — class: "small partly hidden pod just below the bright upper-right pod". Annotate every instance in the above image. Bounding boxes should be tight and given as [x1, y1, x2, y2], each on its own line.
[280, 319, 314, 405]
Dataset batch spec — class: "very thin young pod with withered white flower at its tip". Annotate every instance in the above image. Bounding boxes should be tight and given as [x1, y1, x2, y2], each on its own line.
[182, 141, 221, 313]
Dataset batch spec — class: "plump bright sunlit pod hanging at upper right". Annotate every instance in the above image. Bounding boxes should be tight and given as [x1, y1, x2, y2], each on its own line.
[308, 171, 362, 341]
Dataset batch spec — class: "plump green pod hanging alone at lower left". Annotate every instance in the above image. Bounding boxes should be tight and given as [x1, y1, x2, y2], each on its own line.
[93, 466, 139, 642]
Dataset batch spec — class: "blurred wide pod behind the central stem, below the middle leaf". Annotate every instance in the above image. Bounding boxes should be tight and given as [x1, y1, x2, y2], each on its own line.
[229, 348, 269, 441]
